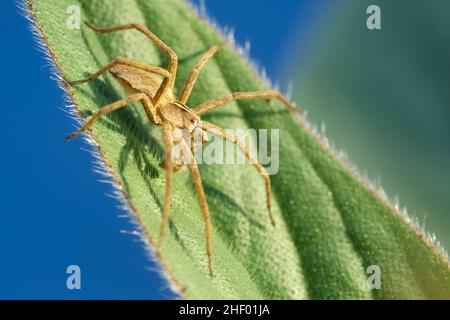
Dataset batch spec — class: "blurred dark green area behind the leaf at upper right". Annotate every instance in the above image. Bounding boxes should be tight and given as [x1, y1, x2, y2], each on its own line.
[285, 0, 450, 249]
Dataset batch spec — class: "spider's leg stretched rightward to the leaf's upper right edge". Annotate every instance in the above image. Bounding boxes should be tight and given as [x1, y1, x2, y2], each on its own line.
[193, 91, 299, 115]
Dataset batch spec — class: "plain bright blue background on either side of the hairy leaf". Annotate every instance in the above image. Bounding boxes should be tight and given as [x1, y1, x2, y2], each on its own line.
[0, 0, 327, 299]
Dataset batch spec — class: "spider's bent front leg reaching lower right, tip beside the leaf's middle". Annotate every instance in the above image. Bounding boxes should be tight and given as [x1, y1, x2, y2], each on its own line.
[202, 120, 275, 226]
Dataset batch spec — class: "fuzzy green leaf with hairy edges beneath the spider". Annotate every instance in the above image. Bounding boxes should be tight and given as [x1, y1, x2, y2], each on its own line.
[25, 0, 450, 299]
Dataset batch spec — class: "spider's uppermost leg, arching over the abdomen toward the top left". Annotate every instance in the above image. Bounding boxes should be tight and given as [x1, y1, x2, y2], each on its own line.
[86, 22, 178, 88]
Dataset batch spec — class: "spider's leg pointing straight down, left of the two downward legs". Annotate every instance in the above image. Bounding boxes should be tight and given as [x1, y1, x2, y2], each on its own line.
[158, 123, 173, 254]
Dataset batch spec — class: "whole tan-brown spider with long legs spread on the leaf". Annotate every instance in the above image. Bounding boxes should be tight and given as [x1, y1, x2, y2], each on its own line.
[66, 22, 297, 276]
